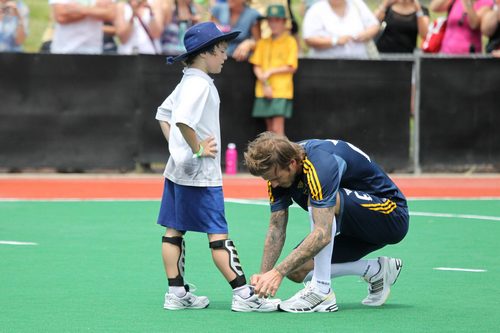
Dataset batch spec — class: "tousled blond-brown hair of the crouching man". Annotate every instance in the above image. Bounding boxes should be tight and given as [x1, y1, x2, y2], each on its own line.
[244, 132, 305, 176]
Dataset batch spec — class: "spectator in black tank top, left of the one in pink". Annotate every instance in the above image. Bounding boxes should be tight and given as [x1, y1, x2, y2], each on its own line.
[374, 0, 429, 53]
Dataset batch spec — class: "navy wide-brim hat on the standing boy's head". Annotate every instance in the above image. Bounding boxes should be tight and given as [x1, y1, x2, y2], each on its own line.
[167, 22, 241, 64]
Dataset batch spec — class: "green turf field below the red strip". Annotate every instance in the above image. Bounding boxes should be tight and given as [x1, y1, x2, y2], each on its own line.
[0, 200, 500, 333]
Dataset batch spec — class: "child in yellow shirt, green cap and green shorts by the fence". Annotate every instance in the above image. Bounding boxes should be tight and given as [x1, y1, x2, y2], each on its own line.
[249, 5, 298, 135]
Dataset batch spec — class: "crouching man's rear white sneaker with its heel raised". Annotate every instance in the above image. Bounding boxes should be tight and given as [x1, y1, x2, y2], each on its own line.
[361, 257, 403, 306]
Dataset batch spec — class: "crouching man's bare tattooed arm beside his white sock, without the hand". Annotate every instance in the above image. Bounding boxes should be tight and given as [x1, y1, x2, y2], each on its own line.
[276, 207, 334, 276]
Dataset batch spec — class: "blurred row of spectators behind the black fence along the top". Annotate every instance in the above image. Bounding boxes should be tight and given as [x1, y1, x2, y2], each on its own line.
[0, 0, 500, 56]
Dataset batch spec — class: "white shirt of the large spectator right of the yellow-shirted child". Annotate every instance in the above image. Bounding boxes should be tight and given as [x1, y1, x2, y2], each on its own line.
[302, 0, 378, 59]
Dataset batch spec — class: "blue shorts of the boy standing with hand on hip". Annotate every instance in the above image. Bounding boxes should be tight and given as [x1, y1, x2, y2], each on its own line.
[158, 178, 228, 234]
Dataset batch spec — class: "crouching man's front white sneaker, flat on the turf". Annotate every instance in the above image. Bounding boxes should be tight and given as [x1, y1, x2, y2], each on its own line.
[279, 282, 339, 313]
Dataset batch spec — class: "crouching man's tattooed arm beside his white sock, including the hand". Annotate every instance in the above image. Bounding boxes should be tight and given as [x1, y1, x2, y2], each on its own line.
[252, 207, 335, 297]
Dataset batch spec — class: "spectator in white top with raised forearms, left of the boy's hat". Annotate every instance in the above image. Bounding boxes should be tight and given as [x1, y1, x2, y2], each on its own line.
[115, 0, 163, 54]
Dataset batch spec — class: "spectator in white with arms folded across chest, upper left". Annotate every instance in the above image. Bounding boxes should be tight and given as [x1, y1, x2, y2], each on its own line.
[49, 0, 115, 54]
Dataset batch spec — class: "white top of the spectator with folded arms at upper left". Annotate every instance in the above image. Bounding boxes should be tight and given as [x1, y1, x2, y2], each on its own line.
[49, 0, 103, 54]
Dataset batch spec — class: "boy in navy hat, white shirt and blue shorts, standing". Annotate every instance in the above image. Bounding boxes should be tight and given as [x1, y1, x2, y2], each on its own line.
[156, 22, 279, 312]
